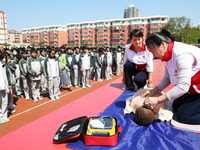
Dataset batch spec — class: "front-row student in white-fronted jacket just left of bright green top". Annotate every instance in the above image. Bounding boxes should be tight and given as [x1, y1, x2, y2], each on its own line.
[44, 49, 61, 101]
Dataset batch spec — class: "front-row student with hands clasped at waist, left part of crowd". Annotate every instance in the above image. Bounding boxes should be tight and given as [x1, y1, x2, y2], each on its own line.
[27, 48, 43, 102]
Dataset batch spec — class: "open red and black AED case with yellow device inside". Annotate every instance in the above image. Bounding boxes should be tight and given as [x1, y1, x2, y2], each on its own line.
[53, 116, 122, 146]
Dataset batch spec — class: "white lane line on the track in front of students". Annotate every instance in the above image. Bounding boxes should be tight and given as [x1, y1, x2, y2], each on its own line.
[9, 81, 97, 119]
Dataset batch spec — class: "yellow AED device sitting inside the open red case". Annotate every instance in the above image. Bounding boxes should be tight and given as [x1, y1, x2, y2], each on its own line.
[86, 116, 116, 136]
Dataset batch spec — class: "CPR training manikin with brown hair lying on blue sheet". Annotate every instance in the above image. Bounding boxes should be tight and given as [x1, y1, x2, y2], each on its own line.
[124, 89, 173, 126]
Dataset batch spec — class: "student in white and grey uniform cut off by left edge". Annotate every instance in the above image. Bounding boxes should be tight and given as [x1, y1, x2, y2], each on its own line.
[0, 50, 11, 124]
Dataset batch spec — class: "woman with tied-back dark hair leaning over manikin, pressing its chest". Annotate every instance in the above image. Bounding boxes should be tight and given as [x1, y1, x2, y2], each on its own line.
[143, 30, 200, 124]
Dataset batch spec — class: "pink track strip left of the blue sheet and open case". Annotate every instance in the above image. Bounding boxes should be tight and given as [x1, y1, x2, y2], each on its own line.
[0, 78, 123, 150]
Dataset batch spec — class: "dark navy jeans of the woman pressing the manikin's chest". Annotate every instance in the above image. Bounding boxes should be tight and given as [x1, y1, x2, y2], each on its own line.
[172, 93, 200, 124]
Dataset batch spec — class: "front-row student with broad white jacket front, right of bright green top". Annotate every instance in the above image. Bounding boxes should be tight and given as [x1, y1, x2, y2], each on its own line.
[79, 47, 91, 89]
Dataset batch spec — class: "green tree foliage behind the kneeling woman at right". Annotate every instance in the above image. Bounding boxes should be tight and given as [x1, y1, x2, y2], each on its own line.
[163, 17, 200, 44]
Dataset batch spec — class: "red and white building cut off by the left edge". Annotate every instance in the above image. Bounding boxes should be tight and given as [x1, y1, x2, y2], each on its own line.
[0, 10, 8, 44]
